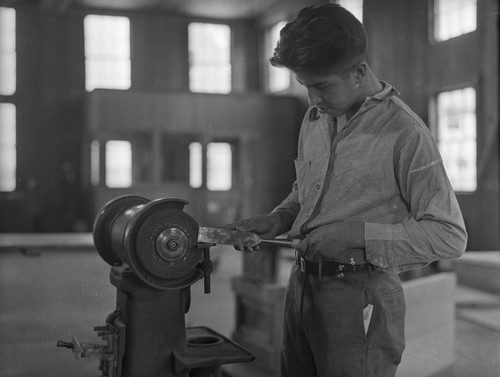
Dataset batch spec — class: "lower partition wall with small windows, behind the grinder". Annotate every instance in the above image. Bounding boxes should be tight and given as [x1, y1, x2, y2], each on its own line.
[82, 90, 304, 226]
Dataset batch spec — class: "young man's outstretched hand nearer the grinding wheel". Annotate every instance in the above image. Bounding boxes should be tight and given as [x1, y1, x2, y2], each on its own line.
[224, 212, 291, 251]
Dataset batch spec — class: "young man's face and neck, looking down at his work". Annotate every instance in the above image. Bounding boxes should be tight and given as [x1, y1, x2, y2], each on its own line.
[295, 65, 363, 119]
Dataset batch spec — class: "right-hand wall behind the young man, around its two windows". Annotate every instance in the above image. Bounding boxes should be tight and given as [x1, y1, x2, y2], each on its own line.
[364, 0, 500, 250]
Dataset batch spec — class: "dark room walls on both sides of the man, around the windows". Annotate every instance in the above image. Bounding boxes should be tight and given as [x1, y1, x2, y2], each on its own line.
[0, 0, 500, 250]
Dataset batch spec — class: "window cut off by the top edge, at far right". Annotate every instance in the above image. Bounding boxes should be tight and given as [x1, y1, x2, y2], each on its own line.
[434, 0, 477, 42]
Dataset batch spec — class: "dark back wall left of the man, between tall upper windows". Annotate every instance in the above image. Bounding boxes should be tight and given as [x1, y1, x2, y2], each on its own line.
[0, 0, 274, 232]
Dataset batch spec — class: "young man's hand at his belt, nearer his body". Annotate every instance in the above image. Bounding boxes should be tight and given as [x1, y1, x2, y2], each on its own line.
[295, 221, 365, 261]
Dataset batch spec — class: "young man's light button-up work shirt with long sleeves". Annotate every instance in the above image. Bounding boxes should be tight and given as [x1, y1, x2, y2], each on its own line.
[274, 82, 467, 273]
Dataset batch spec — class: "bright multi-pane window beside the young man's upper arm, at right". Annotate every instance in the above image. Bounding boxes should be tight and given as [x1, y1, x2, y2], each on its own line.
[437, 88, 477, 191]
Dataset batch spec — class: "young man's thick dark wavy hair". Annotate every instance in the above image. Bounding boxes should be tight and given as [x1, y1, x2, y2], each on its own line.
[270, 4, 368, 73]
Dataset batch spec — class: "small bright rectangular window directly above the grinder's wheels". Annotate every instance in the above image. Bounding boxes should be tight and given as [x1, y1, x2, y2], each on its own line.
[106, 140, 132, 188]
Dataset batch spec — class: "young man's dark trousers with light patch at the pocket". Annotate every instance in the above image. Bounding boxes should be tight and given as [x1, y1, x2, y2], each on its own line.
[281, 265, 406, 377]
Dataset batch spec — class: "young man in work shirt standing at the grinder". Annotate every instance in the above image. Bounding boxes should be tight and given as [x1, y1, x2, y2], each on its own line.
[229, 4, 467, 377]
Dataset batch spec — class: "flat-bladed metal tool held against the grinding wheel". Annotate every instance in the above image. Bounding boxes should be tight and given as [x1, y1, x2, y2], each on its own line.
[198, 227, 293, 248]
